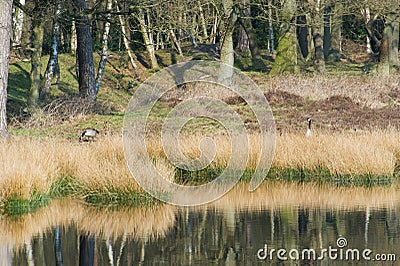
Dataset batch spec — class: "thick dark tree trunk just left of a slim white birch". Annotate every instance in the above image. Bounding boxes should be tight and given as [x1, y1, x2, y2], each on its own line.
[74, 0, 97, 101]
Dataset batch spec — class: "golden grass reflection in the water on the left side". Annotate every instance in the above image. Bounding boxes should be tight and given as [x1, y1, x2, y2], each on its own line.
[0, 199, 175, 250]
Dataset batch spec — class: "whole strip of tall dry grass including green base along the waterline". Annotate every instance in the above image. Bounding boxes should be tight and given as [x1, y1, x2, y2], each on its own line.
[0, 130, 400, 214]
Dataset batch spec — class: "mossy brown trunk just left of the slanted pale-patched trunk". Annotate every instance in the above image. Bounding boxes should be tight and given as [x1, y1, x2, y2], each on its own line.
[28, 16, 44, 108]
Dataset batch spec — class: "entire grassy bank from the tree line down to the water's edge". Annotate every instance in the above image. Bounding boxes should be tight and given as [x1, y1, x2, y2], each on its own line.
[5, 54, 400, 214]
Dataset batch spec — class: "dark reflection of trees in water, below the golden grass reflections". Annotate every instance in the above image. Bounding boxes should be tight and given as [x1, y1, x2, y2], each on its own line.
[7, 208, 400, 265]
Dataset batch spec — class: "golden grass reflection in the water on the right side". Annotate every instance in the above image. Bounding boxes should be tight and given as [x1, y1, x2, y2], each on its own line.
[212, 181, 400, 210]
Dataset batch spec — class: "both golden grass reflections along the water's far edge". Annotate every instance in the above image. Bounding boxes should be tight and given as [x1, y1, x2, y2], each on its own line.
[0, 181, 400, 250]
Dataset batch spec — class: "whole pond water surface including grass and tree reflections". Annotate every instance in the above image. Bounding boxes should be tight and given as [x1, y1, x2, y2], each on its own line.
[0, 184, 400, 265]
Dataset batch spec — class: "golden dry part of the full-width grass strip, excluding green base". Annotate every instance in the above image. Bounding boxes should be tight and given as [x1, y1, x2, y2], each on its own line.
[0, 130, 400, 205]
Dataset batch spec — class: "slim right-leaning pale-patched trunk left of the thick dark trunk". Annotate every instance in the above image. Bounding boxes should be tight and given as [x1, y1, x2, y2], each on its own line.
[39, 2, 61, 99]
